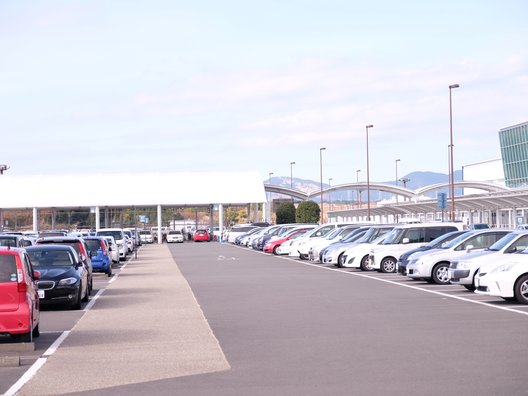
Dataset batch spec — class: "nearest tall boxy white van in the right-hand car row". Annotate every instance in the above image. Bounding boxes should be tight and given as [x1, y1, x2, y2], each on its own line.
[368, 223, 464, 272]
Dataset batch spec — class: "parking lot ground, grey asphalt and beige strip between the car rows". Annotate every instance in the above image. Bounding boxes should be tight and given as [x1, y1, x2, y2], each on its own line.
[0, 242, 528, 395]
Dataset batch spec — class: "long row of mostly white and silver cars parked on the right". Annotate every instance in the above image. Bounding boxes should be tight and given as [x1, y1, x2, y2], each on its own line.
[268, 223, 528, 304]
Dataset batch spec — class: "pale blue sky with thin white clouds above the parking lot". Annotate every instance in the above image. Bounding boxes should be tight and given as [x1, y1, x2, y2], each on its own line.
[0, 0, 528, 185]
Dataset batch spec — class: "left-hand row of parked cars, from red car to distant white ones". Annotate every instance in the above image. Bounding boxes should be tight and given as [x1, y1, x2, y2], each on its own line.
[0, 228, 141, 342]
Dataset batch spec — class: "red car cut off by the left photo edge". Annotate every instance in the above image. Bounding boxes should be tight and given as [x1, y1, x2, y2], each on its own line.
[0, 247, 40, 342]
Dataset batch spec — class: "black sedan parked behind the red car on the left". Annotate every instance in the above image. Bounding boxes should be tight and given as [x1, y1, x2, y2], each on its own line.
[26, 245, 89, 309]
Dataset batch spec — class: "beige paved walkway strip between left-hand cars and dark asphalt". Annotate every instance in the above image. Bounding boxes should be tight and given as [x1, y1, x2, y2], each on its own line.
[18, 245, 230, 395]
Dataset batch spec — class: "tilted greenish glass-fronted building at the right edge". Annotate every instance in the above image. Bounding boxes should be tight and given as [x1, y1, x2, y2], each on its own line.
[499, 122, 528, 188]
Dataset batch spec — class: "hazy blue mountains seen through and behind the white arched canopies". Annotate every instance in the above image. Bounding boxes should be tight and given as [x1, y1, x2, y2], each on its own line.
[265, 170, 462, 202]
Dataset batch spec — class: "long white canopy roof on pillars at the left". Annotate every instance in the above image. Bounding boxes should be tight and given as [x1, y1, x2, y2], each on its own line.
[0, 171, 266, 209]
